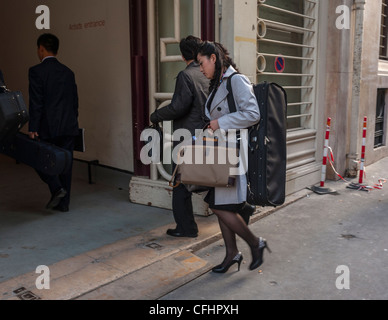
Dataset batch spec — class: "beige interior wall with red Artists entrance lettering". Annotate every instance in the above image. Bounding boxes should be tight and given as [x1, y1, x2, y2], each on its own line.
[0, 0, 134, 171]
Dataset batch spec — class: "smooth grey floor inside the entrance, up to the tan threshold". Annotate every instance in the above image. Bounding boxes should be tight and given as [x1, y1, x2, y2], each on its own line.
[0, 155, 174, 282]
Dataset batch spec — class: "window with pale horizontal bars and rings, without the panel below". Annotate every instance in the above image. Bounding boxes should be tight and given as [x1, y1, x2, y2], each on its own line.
[258, 0, 318, 129]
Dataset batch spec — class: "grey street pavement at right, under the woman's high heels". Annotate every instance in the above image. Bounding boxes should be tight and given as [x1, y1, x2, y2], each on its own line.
[163, 159, 388, 301]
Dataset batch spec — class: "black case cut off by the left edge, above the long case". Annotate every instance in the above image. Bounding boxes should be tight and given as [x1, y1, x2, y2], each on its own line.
[0, 80, 29, 142]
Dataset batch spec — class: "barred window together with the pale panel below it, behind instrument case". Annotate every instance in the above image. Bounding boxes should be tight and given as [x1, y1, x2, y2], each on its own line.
[257, 0, 319, 169]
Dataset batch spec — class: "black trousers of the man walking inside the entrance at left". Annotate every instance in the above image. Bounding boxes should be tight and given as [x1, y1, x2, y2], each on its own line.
[36, 137, 75, 206]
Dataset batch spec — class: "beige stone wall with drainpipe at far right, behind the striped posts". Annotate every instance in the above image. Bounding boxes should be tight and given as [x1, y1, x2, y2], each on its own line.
[325, 0, 388, 178]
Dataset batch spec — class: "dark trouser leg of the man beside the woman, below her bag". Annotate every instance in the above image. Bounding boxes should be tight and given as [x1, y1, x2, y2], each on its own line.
[172, 179, 198, 234]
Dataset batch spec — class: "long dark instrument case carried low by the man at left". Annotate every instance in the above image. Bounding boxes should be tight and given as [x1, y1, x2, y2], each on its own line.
[0, 133, 73, 175]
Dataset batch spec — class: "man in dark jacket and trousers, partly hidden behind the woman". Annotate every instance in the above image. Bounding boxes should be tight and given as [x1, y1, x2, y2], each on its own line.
[151, 36, 209, 238]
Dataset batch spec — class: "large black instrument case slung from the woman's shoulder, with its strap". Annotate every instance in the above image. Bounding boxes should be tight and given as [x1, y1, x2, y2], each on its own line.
[227, 74, 287, 207]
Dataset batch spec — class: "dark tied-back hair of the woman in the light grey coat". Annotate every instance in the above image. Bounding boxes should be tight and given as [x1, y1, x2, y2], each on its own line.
[198, 41, 238, 91]
